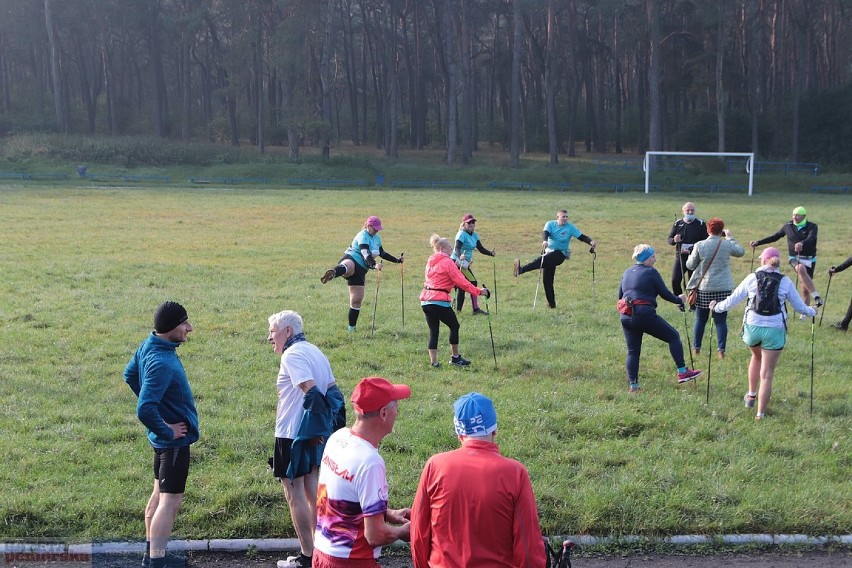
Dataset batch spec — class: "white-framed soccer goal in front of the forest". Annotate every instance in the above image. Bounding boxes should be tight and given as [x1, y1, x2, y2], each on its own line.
[642, 152, 754, 195]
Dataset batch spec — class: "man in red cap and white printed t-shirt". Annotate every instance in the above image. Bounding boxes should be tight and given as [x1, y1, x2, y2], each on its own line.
[313, 377, 411, 568]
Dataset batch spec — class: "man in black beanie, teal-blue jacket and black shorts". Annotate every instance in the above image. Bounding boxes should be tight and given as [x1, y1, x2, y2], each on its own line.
[124, 302, 199, 568]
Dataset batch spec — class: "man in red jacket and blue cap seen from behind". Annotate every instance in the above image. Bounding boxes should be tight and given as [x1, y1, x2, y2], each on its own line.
[411, 392, 546, 568]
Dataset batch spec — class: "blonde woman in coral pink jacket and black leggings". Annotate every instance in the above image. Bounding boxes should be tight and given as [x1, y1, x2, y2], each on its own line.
[420, 234, 491, 367]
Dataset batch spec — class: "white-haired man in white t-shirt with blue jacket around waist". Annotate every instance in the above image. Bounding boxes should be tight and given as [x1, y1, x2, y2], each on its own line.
[268, 310, 346, 568]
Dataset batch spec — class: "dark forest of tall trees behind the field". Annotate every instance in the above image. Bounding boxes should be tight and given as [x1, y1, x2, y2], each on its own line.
[0, 0, 852, 164]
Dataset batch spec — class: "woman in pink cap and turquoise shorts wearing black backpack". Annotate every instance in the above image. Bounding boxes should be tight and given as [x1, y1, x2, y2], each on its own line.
[710, 247, 816, 420]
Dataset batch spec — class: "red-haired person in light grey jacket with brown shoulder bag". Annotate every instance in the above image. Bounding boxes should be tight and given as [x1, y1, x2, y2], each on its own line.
[686, 217, 745, 359]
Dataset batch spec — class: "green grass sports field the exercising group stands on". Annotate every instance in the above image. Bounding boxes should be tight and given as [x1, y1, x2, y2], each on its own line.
[0, 184, 852, 540]
